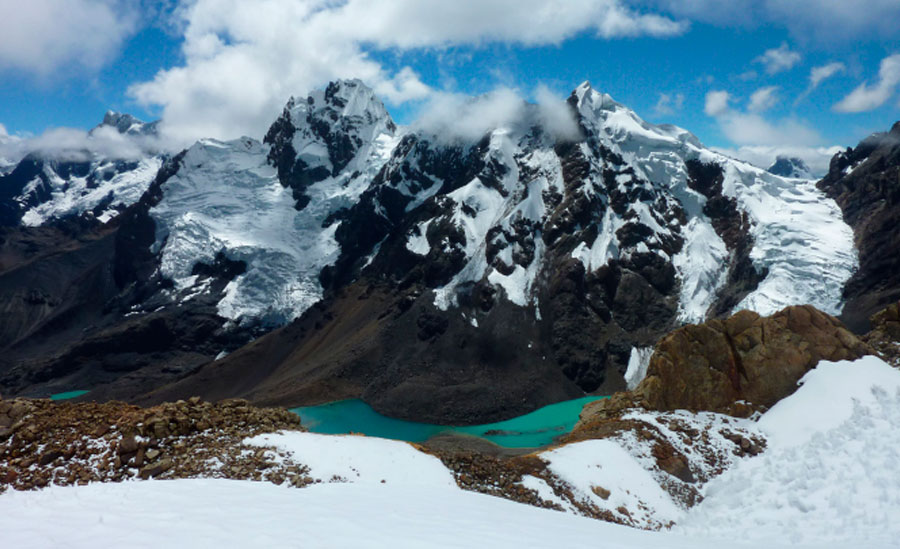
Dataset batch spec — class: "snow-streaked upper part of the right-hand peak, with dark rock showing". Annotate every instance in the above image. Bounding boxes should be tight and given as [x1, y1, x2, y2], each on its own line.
[336, 83, 856, 322]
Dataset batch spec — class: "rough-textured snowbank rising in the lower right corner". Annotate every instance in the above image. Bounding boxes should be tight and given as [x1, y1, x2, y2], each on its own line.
[675, 356, 900, 547]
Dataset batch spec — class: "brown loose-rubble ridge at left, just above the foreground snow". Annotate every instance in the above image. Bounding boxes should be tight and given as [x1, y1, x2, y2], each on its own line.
[0, 398, 311, 492]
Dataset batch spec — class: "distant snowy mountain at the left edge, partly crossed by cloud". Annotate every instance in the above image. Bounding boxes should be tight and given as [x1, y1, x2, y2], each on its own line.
[0, 111, 165, 226]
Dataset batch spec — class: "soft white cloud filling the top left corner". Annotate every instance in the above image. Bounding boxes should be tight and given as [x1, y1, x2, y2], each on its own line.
[0, 0, 137, 78]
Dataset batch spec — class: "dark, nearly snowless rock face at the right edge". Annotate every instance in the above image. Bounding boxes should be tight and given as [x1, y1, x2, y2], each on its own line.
[818, 122, 900, 333]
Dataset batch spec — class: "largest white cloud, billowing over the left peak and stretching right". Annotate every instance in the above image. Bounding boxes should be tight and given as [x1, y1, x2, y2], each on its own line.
[129, 0, 687, 141]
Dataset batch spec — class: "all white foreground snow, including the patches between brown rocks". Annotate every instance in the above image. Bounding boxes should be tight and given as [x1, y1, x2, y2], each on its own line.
[0, 357, 900, 548]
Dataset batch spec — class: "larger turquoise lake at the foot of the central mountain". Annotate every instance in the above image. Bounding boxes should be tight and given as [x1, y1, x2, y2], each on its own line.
[291, 396, 608, 448]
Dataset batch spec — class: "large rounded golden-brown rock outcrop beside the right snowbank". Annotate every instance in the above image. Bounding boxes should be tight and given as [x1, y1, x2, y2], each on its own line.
[596, 305, 873, 417]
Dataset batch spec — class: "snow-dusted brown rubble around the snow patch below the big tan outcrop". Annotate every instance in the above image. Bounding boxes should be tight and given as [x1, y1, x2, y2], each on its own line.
[422, 402, 766, 529]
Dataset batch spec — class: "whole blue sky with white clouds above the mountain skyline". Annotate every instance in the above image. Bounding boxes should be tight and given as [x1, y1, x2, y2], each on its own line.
[0, 0, 900, 173]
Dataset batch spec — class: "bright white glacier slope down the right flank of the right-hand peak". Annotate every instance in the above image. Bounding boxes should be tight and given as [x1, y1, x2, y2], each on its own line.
[575, 84, 856, 322]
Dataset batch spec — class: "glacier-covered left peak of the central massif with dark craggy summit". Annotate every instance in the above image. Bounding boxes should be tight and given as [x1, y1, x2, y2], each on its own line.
[150, 82, 395, 327]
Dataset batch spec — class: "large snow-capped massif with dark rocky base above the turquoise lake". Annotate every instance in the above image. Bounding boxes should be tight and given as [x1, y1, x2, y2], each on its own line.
[151, 82, 857, 422]
